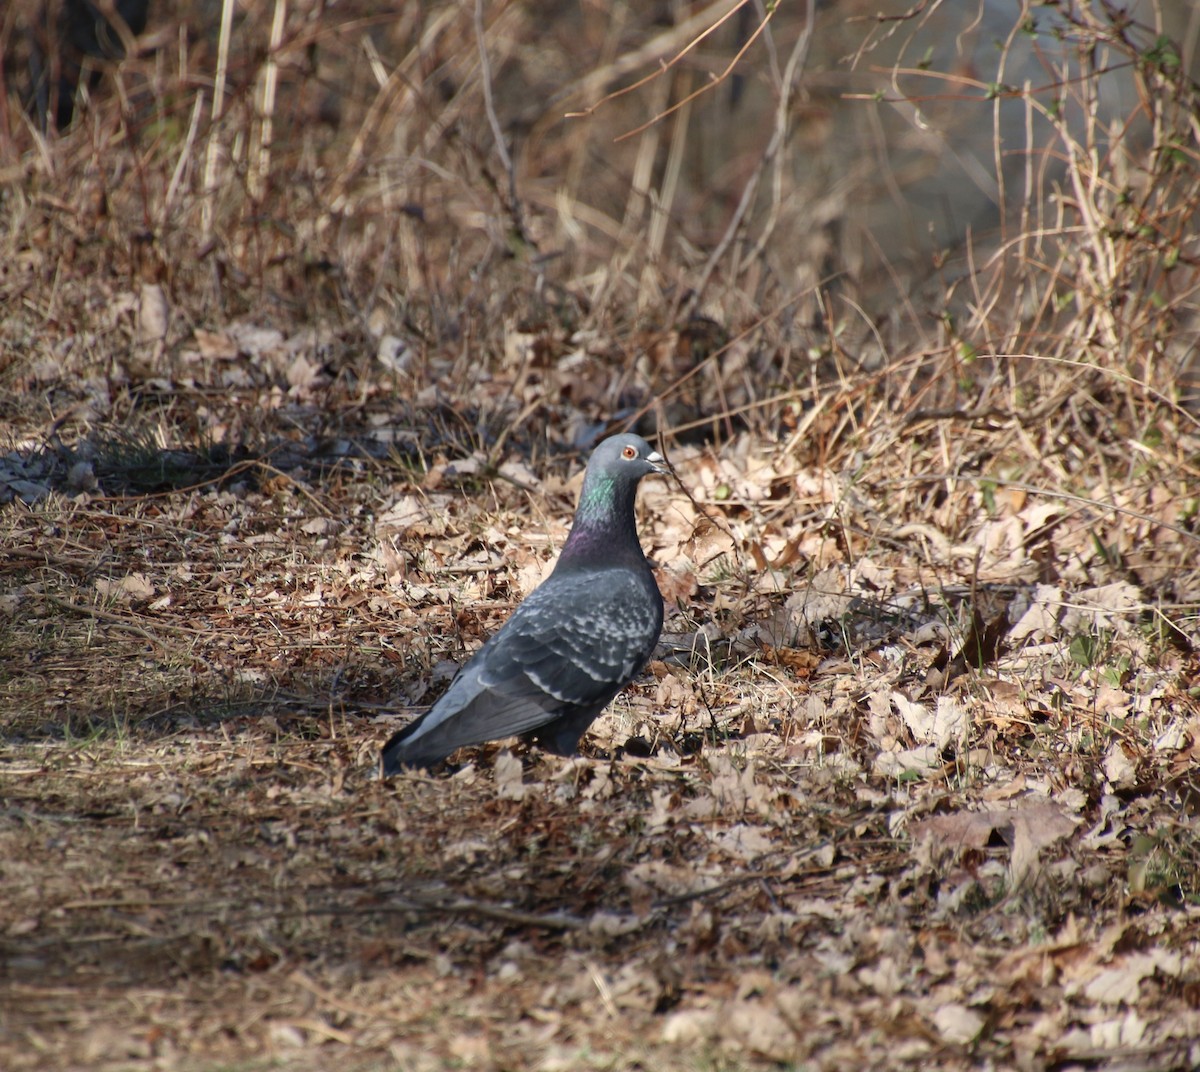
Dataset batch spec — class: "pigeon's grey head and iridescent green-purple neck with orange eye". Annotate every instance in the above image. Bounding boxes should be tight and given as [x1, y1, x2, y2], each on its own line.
[560, 432, 671, 563]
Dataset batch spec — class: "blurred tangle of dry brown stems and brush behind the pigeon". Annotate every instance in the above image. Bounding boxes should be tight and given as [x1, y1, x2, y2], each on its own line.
[0, 0, 1200, 460]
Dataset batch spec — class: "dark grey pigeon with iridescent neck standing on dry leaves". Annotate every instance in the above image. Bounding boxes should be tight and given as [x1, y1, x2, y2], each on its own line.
[383, 433, 670, 777]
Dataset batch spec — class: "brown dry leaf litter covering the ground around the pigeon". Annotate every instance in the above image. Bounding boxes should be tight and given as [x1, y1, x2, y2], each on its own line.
[0, 381, 1200, 1068]
